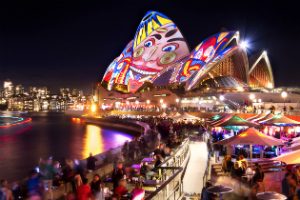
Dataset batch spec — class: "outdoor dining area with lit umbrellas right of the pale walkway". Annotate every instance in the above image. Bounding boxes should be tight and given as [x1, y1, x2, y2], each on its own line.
[204, 113, 300, 199]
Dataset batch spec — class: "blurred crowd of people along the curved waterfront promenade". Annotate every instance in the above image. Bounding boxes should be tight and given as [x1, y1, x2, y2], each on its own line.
[0, 115, 203, 200]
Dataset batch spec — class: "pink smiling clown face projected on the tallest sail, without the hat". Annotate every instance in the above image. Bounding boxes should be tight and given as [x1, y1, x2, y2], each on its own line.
[130, 24, 189, 82]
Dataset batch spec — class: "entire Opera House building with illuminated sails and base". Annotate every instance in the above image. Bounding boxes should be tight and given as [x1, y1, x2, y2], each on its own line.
[98, 12, 274, 105]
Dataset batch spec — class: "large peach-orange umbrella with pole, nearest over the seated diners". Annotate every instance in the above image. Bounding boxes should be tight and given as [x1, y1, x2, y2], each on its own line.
[215, 128, 283, 159]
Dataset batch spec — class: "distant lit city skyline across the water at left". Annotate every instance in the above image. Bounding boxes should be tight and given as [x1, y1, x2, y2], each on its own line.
[0, 81, 87, 112]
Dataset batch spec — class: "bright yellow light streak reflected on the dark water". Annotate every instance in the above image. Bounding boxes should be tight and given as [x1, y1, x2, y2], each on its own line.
[82, 124, 104, 158]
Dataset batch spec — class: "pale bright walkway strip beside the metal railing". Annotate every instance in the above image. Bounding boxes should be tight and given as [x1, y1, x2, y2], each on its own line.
[183, 142, 208, 196]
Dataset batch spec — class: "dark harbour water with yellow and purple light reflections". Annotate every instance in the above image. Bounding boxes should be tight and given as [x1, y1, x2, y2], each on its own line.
[0, 114, 131, 181]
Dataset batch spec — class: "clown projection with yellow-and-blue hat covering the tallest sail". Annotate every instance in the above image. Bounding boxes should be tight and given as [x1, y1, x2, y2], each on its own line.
[102, 11, 189, 92]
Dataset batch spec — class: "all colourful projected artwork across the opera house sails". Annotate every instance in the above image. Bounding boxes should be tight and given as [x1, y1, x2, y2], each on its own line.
[102, 11, 273, 93]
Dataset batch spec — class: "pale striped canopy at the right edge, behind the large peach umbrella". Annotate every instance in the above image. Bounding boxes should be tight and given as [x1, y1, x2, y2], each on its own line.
[259, 115, 300, 126]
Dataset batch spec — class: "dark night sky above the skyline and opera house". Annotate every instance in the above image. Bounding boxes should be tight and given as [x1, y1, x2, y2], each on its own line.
[0, 0, 300, 91]
